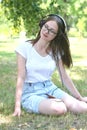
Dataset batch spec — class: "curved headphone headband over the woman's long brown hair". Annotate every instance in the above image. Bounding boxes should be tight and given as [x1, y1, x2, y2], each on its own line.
[39, 14, 67, 32]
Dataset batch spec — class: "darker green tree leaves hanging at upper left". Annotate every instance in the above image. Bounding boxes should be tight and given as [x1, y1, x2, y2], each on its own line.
[2, 0, 41, 34]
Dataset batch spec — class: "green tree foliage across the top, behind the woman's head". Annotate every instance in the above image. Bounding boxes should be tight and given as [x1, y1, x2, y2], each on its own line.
[1, 0, 87, 36]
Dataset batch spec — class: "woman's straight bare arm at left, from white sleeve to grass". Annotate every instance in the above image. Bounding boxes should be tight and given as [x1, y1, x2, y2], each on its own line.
[13, 53, 26, 116]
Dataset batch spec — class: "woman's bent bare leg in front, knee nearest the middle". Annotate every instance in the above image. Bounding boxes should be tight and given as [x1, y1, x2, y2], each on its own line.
[39, 99, 67, 115]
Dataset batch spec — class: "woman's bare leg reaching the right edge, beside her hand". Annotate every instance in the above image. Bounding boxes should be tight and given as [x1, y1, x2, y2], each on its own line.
[62, 94, 87, 113]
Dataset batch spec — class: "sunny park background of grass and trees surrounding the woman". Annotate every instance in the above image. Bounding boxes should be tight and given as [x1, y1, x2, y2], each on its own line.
[0, 0, 87, 130]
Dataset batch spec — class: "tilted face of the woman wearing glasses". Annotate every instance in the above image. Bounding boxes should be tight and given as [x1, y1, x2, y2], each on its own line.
[40, 21, 58, 42]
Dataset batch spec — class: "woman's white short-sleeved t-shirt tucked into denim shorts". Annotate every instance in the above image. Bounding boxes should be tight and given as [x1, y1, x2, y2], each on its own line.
[15, 42, 56, 83]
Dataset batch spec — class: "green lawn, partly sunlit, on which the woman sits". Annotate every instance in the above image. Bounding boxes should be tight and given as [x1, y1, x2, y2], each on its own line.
[0, 39, 87, 130]
